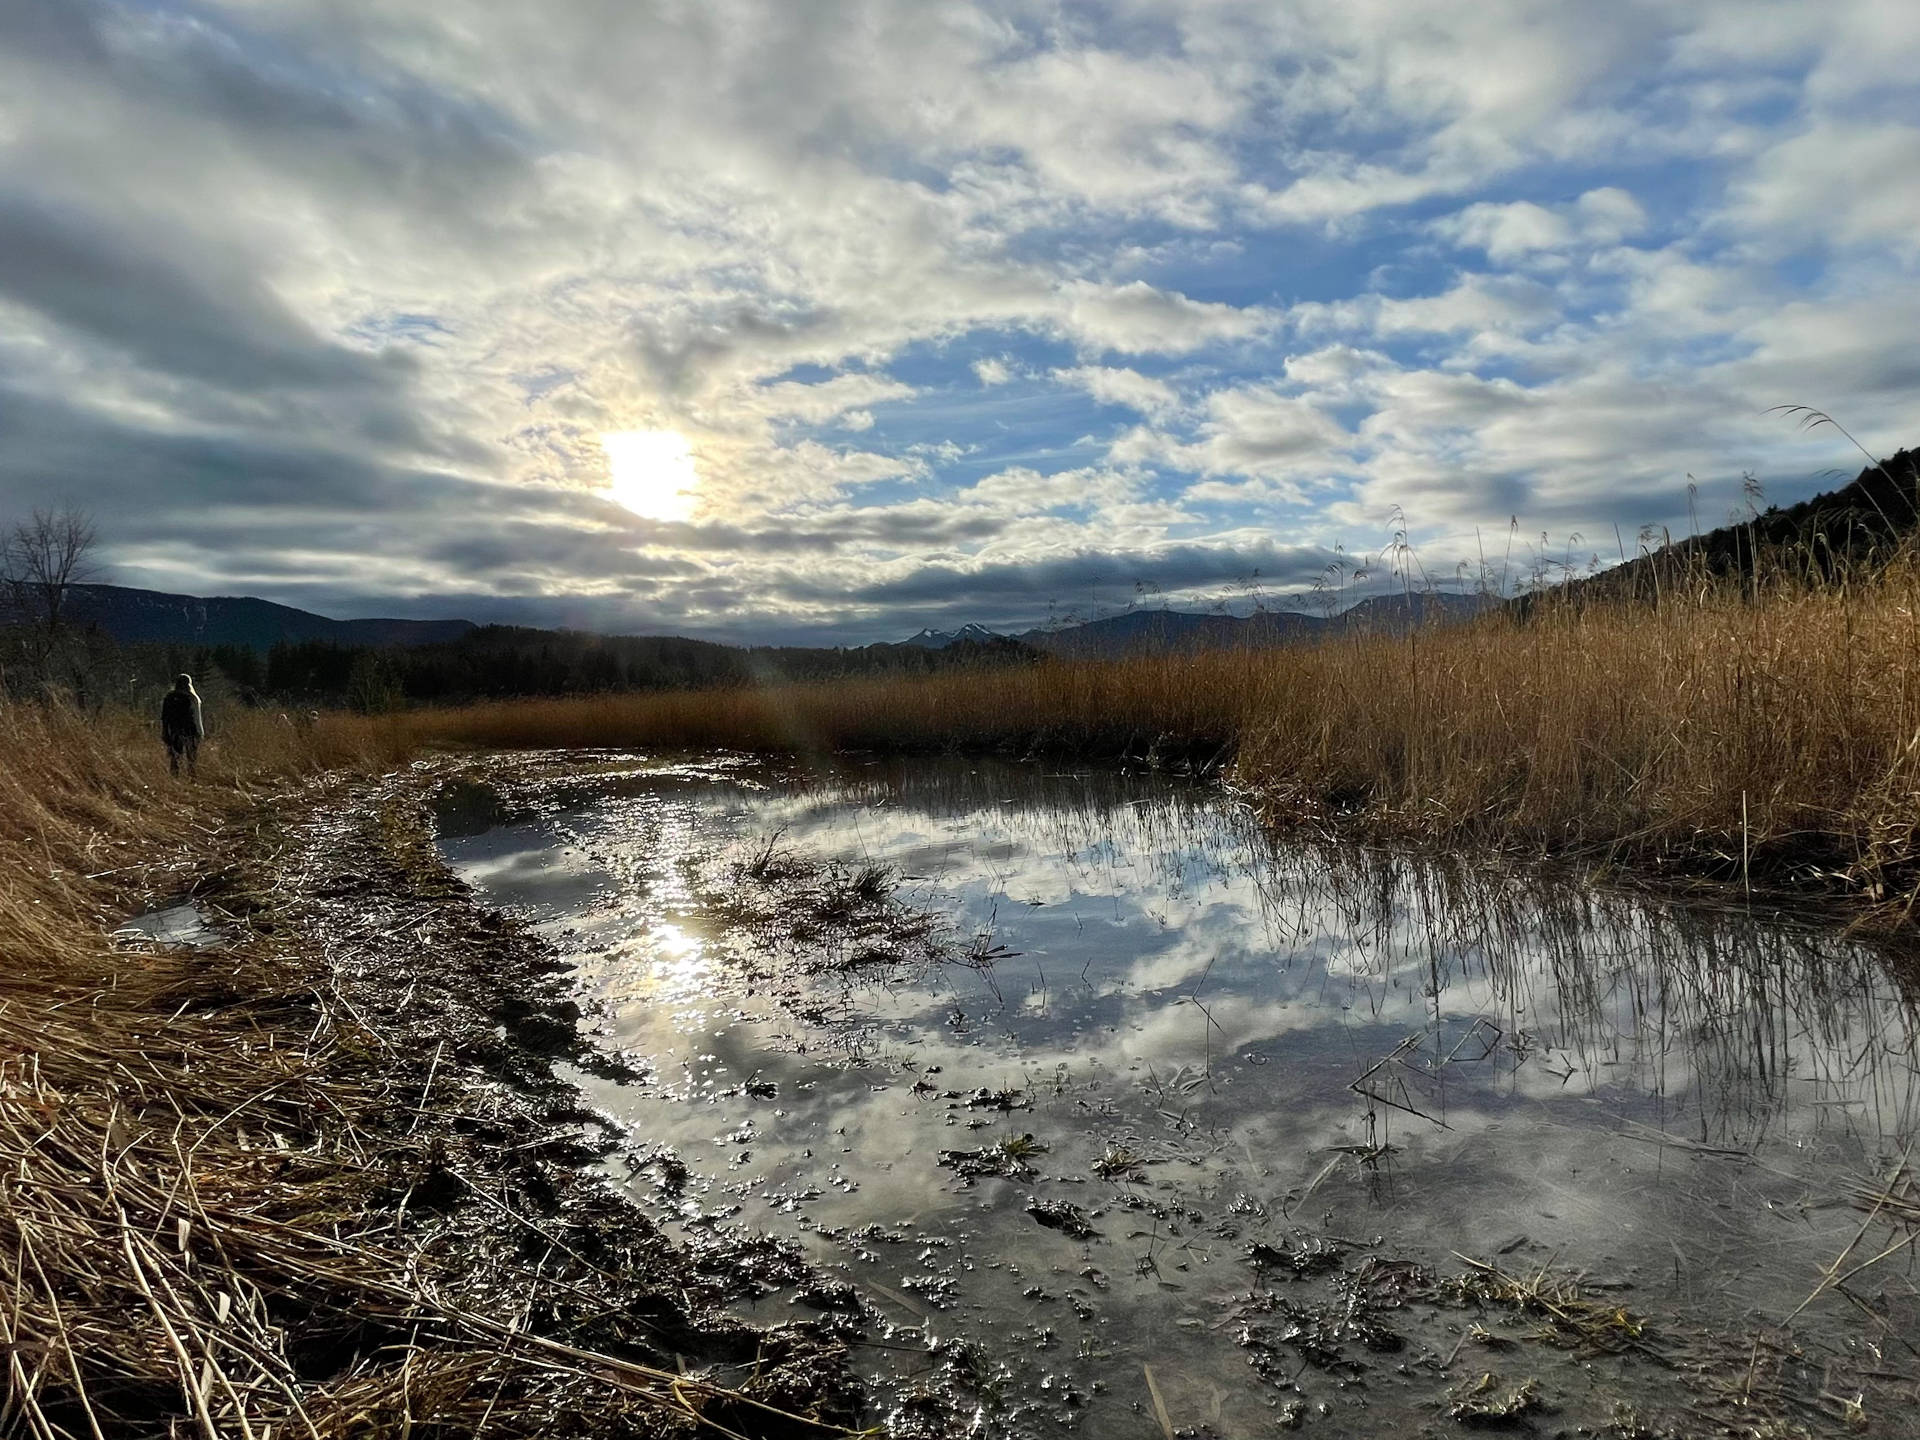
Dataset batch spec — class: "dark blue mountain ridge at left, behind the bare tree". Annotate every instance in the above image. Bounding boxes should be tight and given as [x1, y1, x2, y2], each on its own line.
[37, 586, 474, 651]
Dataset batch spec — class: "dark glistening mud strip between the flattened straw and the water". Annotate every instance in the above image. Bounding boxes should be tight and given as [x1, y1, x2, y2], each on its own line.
[257, 772, 879, 1434]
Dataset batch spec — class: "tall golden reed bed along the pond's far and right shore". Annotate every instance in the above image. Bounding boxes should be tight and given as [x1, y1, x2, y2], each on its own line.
[401, 561, 1920, 914]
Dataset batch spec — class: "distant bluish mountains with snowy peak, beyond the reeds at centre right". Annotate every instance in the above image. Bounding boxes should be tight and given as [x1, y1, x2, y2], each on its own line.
[902, 589, 1500, 660]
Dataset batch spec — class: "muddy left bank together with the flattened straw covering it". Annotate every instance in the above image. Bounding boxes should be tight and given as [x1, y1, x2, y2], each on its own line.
[0, 768, 862, 1436]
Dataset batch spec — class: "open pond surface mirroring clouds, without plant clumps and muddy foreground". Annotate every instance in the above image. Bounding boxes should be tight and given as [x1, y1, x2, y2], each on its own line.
[444, 762, 1920, 1434]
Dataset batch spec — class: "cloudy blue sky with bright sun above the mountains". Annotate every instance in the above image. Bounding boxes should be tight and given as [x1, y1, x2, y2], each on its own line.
[0, 0, 1920, 643]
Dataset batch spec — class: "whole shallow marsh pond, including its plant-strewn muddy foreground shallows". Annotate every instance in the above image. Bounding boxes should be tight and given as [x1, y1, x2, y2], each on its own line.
[442, 755, 1920, 1438]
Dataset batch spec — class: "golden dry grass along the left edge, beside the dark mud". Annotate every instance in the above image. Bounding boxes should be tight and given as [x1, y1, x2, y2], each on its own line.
[0, 705, 414, 1438]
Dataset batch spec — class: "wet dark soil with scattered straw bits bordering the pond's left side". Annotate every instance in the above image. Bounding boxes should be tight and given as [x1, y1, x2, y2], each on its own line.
[132, 766, 866, 1436]
